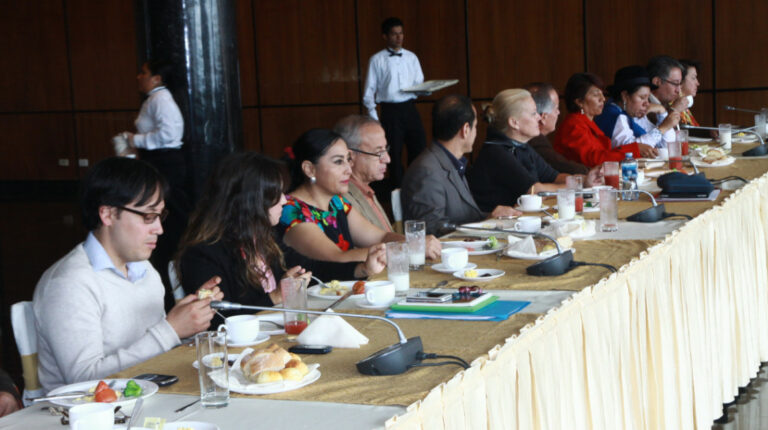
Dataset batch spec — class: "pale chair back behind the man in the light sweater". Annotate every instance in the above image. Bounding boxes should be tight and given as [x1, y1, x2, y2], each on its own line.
[11, 302, 44, 406]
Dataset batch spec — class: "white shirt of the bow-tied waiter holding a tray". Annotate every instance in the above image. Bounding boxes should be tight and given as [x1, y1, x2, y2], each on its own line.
[363, 49, 424, 120]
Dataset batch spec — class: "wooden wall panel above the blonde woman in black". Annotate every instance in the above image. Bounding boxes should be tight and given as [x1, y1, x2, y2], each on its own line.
[468, 0, 584, 98]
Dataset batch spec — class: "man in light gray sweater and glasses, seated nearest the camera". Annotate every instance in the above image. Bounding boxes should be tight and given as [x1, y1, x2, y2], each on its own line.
[33, 158, 223, 391]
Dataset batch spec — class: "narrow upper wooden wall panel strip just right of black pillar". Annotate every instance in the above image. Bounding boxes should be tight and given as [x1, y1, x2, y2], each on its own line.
[236, 0, 259, 106]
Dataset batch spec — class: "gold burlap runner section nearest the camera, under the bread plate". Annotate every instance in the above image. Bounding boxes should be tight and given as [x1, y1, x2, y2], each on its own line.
[112, 312, 539, 405]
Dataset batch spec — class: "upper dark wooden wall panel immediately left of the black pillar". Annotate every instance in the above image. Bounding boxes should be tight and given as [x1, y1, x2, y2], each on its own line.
[66, 0, 141, 110]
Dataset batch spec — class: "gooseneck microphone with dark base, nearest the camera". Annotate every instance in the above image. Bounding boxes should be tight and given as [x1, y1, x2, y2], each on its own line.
[211, 300, 424, 375]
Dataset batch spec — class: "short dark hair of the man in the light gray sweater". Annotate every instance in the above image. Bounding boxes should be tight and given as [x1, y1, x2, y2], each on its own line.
[80, 157, 168, 231]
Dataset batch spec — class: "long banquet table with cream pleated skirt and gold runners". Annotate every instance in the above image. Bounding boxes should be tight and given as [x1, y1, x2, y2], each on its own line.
[0, 145, 768, 429]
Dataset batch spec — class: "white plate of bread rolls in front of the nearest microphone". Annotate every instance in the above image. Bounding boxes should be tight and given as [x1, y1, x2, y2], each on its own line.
[210, 343, 320, 394]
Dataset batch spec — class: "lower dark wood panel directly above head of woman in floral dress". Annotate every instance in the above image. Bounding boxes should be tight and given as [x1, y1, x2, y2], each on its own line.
[261, 105, 360, 158]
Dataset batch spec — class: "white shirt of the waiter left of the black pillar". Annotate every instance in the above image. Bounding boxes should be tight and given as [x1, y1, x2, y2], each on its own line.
[133, 86, 184, 151]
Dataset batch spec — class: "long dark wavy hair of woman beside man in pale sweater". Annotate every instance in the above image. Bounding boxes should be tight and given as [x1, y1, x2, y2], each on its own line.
[175, 152, 288, 287]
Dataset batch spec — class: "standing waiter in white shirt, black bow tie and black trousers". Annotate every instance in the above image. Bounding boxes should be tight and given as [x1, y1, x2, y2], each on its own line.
[363, 17, 426, 188]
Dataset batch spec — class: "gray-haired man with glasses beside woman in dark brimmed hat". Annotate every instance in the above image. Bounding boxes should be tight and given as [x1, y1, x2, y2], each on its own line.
[646, 55, 688, 127]
